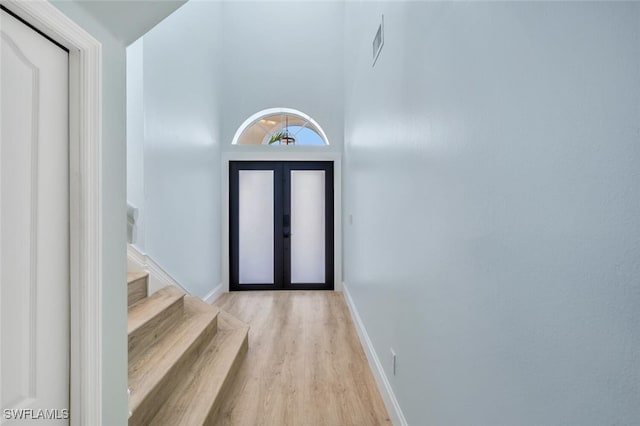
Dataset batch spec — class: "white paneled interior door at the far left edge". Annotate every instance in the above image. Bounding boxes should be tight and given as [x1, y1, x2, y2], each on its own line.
[0, 10, 69, 425]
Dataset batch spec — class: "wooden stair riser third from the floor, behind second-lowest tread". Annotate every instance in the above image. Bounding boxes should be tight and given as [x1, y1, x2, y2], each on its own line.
[129, 298, 184, 364]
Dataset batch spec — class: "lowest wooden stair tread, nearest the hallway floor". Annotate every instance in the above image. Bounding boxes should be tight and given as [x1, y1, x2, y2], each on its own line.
[150, 311, 249, 426]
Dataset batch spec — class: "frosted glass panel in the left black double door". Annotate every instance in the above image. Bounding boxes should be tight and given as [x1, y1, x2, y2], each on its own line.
[238, 170, 274, 284]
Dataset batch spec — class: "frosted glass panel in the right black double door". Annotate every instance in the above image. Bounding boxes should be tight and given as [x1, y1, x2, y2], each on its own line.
[291, 170, 325, 284]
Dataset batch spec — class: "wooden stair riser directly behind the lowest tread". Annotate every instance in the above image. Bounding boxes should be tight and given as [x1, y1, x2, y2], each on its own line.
[129, 317, 218, 426]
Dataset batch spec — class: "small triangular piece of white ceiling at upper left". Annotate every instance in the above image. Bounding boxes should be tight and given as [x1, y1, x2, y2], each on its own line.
[78, 0, 187, 45]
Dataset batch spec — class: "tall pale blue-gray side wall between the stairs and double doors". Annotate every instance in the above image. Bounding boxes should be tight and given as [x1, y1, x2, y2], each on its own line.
[142, 2, 222, 297]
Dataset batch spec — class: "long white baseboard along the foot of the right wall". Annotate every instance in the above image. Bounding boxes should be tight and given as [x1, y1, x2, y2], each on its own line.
[342, 282, 408, 426]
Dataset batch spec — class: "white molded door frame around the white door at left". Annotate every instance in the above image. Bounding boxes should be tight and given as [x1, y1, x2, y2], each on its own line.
[0, 0, 102, 426]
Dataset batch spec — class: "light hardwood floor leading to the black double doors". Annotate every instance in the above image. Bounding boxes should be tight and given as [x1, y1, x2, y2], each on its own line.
[214, 291, 391, 426]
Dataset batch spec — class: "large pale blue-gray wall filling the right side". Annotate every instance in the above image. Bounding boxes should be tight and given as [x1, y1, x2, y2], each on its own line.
[344, 2, 640, 426]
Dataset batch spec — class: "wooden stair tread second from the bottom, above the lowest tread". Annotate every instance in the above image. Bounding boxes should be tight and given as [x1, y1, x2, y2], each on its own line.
[129, 296, 219, 412]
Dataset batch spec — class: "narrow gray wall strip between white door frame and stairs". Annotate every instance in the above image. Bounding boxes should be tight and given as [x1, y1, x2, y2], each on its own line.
[53, 1, 129, 425]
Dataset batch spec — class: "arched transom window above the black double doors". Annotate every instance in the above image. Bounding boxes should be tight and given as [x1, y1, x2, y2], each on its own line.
[233, 108, 329, 145]
